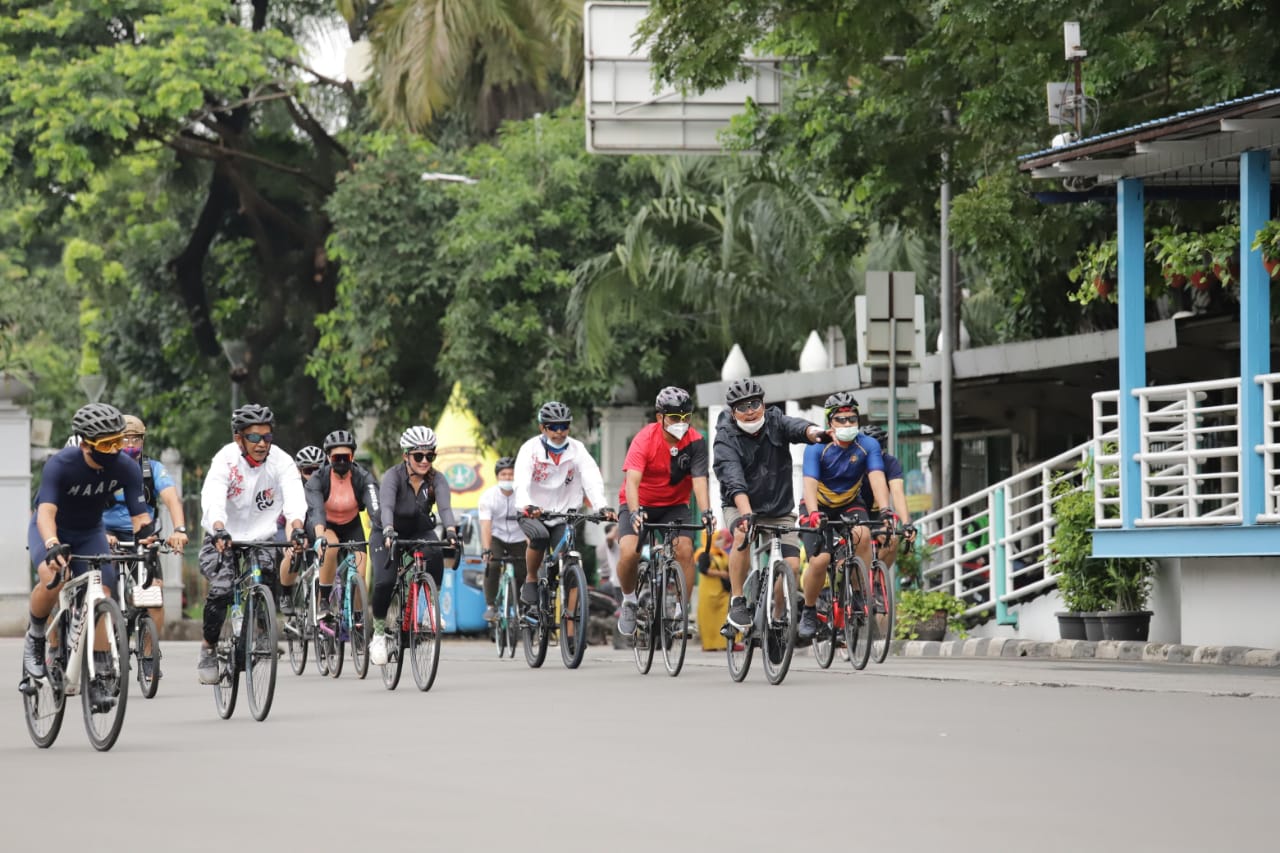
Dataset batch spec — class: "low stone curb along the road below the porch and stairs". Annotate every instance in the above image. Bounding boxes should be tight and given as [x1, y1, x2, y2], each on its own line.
[892, 637, 1280, 667]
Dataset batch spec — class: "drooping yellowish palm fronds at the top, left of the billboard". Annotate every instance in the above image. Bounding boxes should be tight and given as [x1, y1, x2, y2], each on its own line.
[338, 0, 582, 136]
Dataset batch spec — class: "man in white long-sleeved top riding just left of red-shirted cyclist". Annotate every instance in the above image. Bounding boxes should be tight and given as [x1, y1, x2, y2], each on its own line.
[516, 401, 613, 605]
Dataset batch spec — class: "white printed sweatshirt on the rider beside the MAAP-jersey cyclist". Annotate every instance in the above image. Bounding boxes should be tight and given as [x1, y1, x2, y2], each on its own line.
[200, 442, 307, 542]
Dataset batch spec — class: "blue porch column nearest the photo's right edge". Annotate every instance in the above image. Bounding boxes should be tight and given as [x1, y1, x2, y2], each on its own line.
[1240, 151, 1271, 524]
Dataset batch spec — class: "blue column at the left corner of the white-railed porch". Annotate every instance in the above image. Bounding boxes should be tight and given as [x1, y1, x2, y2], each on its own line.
[1116, 178, 1147, 528]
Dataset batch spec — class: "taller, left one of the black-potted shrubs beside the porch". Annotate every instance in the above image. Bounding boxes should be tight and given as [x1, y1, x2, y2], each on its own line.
[1050, 483, 1107, 639]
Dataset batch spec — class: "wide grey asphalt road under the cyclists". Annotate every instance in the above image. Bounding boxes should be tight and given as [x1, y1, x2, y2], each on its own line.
[0, 639, 1280, 853]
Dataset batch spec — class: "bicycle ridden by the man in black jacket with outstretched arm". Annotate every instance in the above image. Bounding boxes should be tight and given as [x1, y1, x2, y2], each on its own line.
[721, 521, 799, 685]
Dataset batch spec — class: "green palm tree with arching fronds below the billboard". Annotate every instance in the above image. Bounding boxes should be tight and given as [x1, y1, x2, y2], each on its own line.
[570, 156, 858, 366]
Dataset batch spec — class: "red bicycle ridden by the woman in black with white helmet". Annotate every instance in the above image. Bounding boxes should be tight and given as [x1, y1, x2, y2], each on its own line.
[381, 539, 453, 692]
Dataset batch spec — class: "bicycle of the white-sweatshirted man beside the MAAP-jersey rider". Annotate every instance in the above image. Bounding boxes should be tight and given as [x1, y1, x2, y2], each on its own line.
[214, 540, 293, 722]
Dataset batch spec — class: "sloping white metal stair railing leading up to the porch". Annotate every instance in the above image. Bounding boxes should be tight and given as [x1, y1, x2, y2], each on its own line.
[915, 442, 1093, 615]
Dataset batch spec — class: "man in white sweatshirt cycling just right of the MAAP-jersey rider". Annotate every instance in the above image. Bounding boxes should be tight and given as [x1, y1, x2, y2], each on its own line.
[196, 403, 307, 684]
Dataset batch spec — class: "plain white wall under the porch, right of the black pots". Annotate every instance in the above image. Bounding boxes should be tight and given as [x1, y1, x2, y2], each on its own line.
[1172, 557, 1280, 648]
